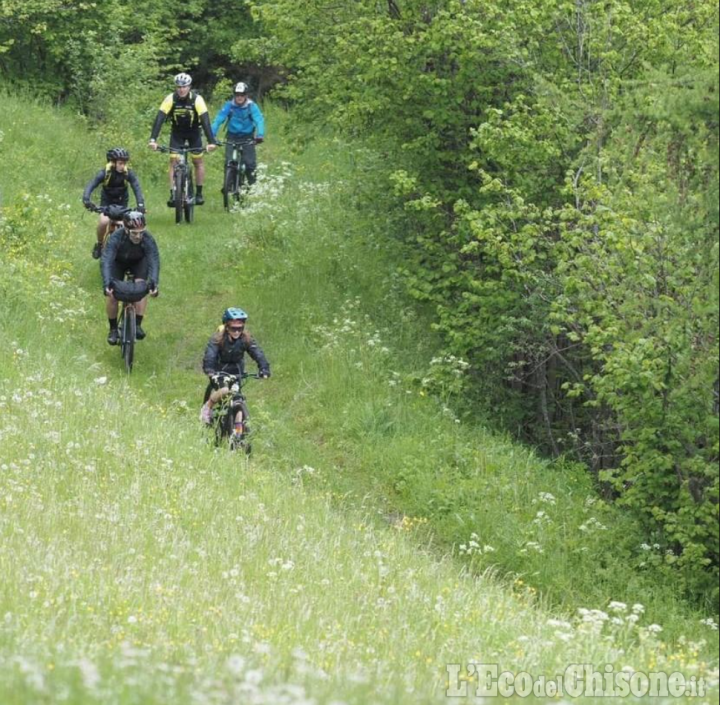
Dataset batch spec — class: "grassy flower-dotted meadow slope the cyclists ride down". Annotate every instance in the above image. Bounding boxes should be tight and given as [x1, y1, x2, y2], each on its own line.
[0, 95, 707, 703]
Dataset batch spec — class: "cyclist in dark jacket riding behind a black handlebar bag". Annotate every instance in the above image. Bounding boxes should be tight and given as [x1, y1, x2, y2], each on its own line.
[100, 211, 160, 345]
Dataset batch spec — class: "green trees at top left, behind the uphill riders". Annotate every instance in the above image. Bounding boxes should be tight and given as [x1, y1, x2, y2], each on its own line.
[0, 0, 252, 108]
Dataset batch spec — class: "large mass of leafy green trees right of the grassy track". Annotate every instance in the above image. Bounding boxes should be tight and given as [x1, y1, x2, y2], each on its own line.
[252, 0, 719, 595]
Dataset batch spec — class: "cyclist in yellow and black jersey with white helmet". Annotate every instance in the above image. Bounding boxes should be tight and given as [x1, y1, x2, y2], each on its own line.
[150, 73, 217, 208]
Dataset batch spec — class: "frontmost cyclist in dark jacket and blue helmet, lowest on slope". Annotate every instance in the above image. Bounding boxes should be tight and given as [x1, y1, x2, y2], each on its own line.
[200, 308, 270, 424]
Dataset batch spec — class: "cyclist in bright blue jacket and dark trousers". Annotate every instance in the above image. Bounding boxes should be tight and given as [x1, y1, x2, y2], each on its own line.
[212, 83, 265, 186]
